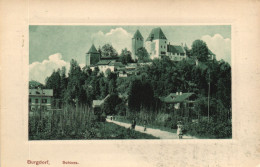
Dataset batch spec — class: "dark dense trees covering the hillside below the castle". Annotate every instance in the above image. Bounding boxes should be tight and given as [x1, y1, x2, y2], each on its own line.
[30, 40, 232, 138]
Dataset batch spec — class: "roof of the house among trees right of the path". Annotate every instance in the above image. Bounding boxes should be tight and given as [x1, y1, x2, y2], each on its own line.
[160, 93, 194, 103]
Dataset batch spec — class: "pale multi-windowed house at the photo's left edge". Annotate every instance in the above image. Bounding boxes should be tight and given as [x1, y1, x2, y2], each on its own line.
[29, 89, 53, 111]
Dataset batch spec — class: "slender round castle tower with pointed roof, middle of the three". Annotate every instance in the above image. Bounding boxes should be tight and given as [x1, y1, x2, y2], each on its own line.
[132, 30, 144, 60]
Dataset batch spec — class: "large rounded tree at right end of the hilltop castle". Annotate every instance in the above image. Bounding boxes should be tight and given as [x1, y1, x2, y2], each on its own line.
[191, 39, 209, 62]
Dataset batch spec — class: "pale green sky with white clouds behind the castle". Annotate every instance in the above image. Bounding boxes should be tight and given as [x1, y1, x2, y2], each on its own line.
[29, 25, 231, 83]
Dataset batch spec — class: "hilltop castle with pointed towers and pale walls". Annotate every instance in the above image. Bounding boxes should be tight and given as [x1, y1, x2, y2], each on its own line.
[86, 27, 216, 66]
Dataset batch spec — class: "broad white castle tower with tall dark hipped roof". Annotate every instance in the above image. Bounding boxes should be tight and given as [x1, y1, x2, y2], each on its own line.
[145, 27, 167, 59]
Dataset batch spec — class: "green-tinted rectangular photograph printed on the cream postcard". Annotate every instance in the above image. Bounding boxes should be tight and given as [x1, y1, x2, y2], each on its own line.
[28, 25, 232, 140]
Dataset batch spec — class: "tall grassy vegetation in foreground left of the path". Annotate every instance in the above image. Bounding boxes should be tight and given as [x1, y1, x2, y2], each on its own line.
[29, 107, 156, 140]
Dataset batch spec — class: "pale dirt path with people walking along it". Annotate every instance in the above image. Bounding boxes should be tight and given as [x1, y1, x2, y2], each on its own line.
[106, 119, 195, 139]
